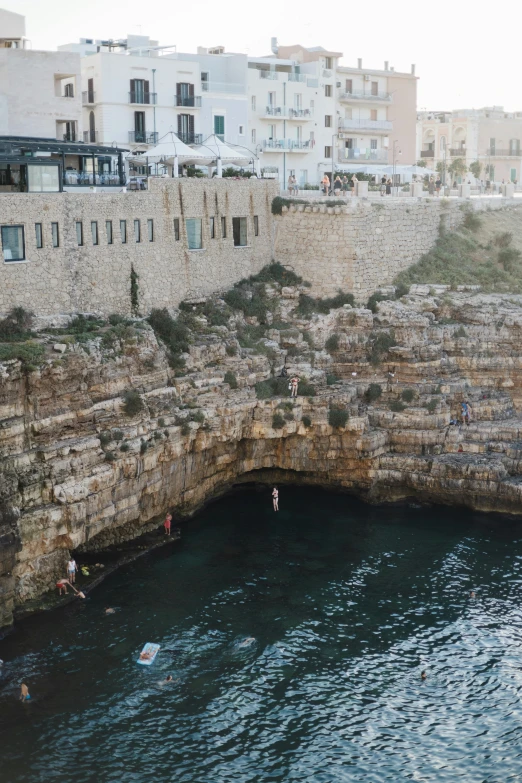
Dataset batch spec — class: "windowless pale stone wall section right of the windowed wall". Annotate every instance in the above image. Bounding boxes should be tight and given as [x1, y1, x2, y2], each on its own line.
[274, 198, 519, 303]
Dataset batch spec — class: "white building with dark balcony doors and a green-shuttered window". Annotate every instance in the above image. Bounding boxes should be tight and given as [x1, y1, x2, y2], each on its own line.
[59, 35, 247, 152]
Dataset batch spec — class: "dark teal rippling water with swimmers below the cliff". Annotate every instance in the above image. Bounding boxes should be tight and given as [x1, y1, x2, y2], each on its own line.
[0, 487, 522, 783]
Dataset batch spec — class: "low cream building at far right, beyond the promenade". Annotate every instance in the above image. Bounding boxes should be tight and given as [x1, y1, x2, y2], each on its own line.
[417, 106, 522, 182]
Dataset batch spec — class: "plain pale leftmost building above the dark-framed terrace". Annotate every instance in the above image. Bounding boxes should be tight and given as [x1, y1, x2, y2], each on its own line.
[0, 9, 82, 141]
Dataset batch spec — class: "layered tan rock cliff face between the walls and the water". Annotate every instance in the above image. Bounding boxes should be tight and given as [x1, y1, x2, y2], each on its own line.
[0, 287, 522, 626]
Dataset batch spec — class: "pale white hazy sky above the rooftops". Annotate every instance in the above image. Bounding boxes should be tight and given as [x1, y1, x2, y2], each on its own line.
[7, 0, 522, 111]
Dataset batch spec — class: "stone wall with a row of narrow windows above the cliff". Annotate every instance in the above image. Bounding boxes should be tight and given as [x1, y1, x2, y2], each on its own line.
[0, 179, 277, 316]
